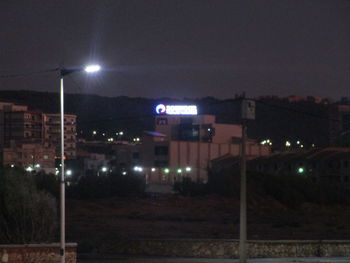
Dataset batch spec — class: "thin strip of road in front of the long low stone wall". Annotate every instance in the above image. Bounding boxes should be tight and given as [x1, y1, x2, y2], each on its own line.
[78, 255, 350, 263]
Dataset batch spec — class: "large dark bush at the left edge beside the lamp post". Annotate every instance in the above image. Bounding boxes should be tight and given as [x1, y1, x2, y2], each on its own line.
[0, 168, 57, 244]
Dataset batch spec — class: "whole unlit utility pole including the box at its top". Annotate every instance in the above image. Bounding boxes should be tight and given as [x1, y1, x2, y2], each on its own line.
[239, 98, 255, 263]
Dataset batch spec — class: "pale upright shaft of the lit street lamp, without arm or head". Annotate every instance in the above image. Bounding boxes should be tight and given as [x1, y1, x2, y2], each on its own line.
[60, 76, 66, 263]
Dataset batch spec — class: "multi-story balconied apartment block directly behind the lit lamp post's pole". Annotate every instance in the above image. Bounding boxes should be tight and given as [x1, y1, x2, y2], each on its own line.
[43, 113, 77, 159]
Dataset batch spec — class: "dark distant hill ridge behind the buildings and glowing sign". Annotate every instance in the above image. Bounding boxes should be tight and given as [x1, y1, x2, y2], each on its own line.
[0, 91, 331, 146]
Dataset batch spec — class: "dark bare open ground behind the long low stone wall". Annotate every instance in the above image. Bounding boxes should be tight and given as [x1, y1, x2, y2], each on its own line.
[67, 196, 350, 253]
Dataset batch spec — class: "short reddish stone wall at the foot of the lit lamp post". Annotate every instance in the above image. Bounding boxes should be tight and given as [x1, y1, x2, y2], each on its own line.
[0, 243, 77, 263]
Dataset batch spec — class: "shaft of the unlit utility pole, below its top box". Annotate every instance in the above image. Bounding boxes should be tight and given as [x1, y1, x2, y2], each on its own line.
[239, 120, 247, 263]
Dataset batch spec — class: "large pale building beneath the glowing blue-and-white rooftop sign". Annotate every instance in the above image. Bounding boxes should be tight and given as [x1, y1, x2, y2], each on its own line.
[136, 106, 270, 184]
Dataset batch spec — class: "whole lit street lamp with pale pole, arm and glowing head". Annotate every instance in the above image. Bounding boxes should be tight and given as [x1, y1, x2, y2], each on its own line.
[59, 65, 101, 263]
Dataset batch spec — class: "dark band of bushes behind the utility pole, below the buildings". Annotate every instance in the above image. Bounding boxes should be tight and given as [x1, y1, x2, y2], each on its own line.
[174, 171, 350, 209]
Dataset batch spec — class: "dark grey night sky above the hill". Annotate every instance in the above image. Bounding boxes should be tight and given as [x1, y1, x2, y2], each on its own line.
[0, 0, 350, 98]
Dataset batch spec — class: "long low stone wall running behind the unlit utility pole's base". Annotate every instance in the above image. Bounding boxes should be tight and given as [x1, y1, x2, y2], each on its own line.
[99, 239, 350, 258]
